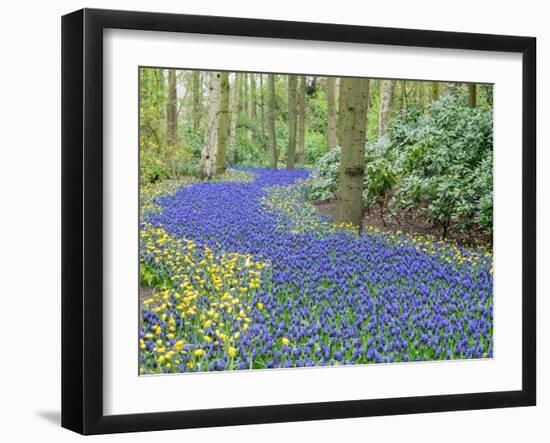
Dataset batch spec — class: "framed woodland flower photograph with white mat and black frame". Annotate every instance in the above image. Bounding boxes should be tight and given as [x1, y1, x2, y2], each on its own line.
[62, 9, 536, 434]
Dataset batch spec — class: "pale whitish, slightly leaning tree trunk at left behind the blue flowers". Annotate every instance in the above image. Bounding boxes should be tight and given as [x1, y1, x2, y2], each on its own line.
[199, 72, 221, 180]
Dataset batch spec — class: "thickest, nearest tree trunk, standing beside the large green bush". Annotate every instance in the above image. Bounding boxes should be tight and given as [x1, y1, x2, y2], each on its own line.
[336, 78, 369, 232]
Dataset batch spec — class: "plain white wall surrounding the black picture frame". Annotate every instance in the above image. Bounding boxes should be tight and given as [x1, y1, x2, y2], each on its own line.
[0, 0, 550, 443]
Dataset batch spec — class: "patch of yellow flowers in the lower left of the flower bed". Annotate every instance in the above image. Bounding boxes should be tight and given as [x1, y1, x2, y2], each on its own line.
[139, 224, 269, 373]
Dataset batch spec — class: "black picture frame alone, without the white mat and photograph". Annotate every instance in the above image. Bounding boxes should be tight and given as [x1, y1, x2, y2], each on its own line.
[62, 9, 536, 434]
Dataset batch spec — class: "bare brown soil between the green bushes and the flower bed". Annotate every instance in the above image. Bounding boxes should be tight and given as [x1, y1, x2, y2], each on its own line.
[313, 201, 491, 250]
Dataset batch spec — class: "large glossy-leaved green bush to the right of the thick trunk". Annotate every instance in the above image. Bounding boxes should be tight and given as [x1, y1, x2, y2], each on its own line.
[389, 96, 493, 235]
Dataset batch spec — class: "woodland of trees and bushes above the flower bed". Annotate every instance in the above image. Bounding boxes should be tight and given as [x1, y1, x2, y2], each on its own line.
[140, 68, 493, 243]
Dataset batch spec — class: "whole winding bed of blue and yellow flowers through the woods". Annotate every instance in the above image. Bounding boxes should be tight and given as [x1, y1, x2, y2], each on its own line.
[139, 170, 493, 374]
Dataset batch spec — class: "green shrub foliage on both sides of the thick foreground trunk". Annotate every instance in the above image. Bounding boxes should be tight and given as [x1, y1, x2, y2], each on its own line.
[305, 93, 493, 236]
